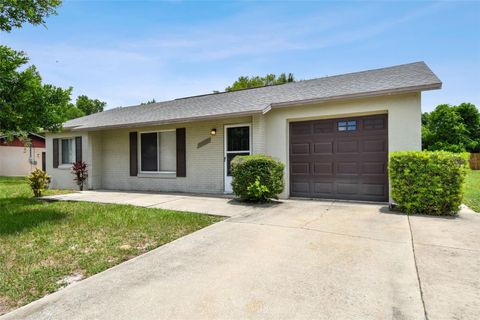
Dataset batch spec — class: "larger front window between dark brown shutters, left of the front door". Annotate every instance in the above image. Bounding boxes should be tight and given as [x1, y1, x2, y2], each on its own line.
[140, 131, 177, 172]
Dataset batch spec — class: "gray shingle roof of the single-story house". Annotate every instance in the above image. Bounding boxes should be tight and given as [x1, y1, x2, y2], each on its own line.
[64, 62, 442, 130]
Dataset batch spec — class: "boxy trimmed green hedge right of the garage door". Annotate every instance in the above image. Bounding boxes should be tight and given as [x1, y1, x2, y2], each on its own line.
[388, 151, 468, 215]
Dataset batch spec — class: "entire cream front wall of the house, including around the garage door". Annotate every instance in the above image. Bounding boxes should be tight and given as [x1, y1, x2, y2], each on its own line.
[46, 93, 421, 198]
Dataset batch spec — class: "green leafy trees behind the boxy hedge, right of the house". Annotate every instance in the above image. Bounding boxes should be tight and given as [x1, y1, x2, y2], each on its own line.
[422, 103, 480, 152]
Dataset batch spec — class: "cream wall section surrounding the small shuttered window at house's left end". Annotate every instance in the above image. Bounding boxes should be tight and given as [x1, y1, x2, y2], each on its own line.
[45, 132, 90, 189]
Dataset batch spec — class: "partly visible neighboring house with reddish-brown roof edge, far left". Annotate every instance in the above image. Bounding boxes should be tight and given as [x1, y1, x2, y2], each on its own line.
[0, 134, 45, 176]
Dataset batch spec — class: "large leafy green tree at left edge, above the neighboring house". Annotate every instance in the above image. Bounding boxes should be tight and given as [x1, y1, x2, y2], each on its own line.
[0, 46, 72, 139]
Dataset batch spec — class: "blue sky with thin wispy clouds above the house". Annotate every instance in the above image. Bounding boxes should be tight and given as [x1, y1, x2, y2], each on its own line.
[0, 0, 480, 111]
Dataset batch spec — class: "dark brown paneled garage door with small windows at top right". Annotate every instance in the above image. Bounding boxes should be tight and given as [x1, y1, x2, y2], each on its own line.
[290, 115, 388, 201]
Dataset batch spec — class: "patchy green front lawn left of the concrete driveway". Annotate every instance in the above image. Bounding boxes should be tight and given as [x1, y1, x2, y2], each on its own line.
[0, 177, 221, 314]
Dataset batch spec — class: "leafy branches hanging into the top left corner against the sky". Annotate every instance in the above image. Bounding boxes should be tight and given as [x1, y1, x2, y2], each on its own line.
[0, 0, 62, 32]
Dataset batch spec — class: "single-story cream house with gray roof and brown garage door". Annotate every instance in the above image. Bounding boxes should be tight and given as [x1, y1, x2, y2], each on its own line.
[47, 62, 442, 201]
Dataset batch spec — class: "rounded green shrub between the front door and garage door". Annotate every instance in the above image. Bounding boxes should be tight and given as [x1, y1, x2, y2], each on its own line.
[231, 155, 284, 202]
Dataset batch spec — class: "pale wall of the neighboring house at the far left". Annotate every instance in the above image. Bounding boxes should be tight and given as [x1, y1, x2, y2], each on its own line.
[0, 145, 45, 176]
